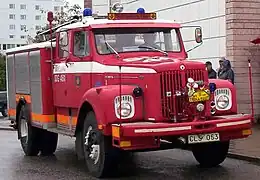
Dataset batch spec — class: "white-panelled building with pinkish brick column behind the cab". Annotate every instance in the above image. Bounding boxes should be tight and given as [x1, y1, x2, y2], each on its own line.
[85, 0, 260, 117]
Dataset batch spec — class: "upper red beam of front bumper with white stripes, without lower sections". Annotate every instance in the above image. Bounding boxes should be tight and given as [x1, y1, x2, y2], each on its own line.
[112, 114, 251, 138]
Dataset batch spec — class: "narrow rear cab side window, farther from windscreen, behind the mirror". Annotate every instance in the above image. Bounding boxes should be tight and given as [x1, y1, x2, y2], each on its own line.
[59, 32, 69, 58]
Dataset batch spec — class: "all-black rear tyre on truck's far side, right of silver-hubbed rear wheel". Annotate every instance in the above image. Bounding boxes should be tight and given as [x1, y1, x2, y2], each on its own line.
[40, 130, 58, 156]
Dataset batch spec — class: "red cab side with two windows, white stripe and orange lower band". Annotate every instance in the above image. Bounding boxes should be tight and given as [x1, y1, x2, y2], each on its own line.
[54, 30, 92, 133]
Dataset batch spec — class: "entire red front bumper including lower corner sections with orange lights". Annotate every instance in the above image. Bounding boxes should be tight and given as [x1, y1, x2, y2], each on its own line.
[112, 114, 252, 150]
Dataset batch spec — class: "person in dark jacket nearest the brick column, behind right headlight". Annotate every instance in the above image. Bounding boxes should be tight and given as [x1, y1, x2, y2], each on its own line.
[219, 59, 235, 84]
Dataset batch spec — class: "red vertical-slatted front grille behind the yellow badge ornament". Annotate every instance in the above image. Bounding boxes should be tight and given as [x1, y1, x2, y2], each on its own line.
[160, 69, 205, 119]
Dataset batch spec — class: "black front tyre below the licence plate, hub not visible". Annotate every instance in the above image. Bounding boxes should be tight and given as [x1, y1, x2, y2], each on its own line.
[192, 141, 229, 168]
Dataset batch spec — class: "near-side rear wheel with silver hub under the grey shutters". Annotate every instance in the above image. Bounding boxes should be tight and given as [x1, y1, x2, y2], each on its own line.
[18, 105, 40, 156]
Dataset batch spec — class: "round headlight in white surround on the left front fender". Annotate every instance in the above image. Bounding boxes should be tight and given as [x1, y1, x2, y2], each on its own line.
[114, 95, 135, 119]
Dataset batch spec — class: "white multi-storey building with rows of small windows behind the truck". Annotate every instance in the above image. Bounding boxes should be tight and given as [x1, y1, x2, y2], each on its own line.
[0, 0, 63, 52]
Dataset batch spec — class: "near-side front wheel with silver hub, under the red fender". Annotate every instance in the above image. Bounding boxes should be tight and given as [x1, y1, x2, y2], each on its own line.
[82, 112, 120, 178]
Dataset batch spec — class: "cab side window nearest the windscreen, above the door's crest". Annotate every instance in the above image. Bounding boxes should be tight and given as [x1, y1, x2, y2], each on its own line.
[73, 31, 89, 57]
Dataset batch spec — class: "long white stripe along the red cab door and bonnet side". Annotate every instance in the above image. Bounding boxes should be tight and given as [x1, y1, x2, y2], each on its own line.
[53, 62, 156, 74]
